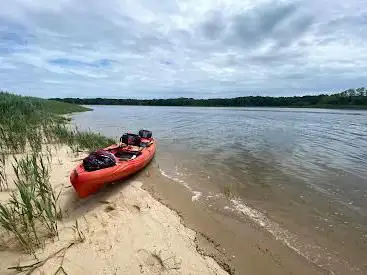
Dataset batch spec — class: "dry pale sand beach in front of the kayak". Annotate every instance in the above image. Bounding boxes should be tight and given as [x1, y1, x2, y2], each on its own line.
[0, 147, 227, 274]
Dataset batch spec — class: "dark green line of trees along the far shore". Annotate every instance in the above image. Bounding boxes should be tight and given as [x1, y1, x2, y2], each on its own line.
[54, 88, 367, 109]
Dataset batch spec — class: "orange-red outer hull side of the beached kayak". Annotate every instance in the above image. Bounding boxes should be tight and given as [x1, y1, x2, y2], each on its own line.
[70, 139, 156, 198]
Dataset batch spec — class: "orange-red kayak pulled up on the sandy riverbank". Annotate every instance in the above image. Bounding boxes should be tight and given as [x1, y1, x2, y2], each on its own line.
[70, 132, 156, 198]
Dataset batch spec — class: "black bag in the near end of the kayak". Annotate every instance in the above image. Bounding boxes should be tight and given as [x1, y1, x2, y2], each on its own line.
[83, 150, 116, 172]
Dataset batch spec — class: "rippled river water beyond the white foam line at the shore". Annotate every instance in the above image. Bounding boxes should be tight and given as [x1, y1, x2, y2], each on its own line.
[74, 106, 367, 273]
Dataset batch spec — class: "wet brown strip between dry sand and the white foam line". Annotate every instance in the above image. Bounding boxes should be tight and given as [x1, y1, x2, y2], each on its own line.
[142, 162, 329, 274]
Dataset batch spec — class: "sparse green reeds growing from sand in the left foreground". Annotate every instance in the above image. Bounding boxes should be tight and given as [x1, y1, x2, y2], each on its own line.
[0, 153, 60, 252]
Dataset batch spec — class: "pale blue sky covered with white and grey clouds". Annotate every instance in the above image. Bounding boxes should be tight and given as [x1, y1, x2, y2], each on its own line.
[0, 0, 367, 98]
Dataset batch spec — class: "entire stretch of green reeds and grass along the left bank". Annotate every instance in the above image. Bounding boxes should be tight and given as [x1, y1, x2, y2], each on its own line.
[0, 93, 114, 253]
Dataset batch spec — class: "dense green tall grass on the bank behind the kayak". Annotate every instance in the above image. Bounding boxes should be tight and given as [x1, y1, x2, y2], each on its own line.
[0, 93, 114, 154]
